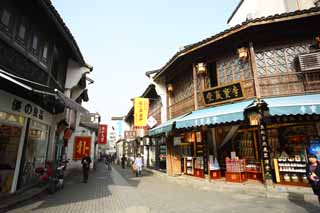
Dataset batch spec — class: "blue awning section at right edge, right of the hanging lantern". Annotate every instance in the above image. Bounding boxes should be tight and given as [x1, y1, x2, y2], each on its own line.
[264, 94, 320, 116]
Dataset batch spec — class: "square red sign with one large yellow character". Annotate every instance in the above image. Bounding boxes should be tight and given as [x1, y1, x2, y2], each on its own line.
[73, 136, 91, 160]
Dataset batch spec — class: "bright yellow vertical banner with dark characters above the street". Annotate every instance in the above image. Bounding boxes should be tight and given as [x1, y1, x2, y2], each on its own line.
[134, 98, 149, 127]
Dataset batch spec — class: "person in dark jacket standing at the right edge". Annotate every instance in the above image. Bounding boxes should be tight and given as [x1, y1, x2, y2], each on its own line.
[307, 155, 320, 203]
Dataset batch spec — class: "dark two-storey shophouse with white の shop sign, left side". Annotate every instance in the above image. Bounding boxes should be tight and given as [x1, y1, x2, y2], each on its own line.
[0, 0, 92, 197]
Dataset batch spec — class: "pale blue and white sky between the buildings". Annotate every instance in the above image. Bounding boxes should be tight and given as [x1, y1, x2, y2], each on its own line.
[52, 0, 239, 122]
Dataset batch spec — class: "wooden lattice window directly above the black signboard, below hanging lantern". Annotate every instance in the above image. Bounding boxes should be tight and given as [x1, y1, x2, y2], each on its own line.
[217, 57, 252, 85]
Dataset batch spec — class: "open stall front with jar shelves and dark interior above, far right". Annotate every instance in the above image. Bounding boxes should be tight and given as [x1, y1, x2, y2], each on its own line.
[270, 124, 318, 187]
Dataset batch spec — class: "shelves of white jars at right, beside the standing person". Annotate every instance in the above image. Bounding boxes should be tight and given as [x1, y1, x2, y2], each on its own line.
[274, 155, 309, 186]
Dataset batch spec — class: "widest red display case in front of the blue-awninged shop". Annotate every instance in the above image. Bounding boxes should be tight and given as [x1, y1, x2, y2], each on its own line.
[226, 159, 248, 182]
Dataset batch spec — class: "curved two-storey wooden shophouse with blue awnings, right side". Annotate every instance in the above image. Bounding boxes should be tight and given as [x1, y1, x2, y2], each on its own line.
[150, 8, 320, 186]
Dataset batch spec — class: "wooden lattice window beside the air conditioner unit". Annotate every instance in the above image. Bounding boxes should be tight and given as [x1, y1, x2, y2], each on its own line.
[256, 44, 309, 76]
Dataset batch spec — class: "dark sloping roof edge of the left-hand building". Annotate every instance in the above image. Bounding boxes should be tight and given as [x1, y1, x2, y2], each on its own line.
[38, 0, 88, 66]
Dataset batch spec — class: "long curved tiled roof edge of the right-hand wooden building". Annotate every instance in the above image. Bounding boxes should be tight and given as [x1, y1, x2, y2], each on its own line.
[154, 7, 320, 79]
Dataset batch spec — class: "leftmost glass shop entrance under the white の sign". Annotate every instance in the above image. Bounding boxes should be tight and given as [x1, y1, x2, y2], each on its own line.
[0, 123, 22, 196]
